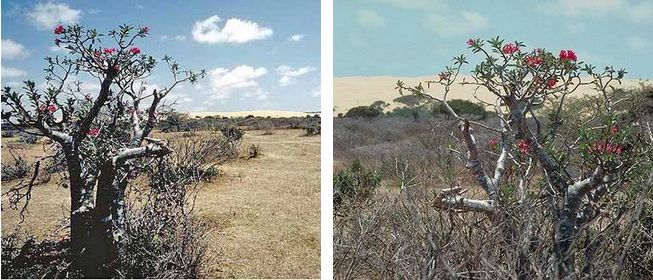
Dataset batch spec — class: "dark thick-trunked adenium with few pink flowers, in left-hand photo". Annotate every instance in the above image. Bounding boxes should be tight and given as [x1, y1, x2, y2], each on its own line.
[2, 25, 205, 277]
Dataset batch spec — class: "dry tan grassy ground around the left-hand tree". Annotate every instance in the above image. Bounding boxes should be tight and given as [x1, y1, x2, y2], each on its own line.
[2, 130, 320, 278]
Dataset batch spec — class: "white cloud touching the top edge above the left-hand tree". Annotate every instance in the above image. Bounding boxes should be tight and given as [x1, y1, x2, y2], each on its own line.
[27, 2, 82, 30]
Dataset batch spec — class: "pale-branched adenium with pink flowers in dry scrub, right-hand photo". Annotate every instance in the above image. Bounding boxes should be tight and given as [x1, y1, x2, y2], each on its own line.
[396, 37, 653, 278]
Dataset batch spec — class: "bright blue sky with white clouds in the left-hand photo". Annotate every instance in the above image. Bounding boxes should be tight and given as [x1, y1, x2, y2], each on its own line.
[2, 0, 320, 111]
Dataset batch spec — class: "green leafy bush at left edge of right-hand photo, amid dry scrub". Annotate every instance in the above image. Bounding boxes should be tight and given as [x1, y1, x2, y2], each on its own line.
[333, 160, 381, 213]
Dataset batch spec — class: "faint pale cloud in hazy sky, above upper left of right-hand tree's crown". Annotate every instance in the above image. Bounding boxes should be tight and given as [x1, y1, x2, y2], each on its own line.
[426, 11, 490, 35]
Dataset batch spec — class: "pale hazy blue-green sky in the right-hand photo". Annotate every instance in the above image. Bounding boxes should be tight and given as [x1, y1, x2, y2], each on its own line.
[334, 0, 653, 79]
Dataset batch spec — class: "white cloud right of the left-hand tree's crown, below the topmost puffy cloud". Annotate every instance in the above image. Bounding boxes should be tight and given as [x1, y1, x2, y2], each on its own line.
[208, 65, 268, 100]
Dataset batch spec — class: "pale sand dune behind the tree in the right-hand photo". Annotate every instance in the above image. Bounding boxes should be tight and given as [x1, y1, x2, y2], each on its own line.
[333, 76, 651, 114]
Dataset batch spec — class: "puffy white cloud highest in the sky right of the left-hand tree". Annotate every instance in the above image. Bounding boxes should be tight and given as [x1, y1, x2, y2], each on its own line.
[193, 15, 274, 44]
